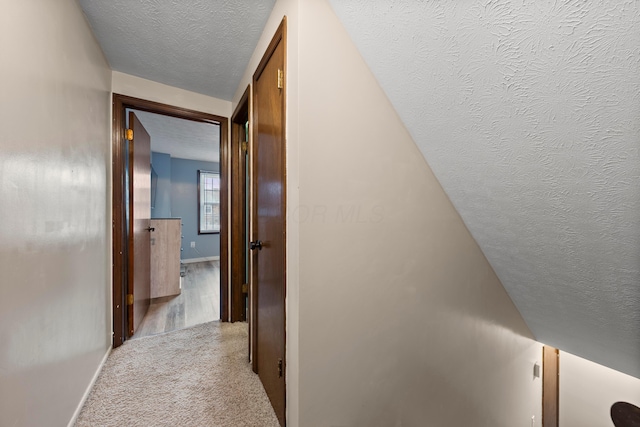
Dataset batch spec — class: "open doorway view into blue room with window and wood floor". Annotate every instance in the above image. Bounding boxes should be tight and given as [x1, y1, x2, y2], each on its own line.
[126, 109, 221, 338]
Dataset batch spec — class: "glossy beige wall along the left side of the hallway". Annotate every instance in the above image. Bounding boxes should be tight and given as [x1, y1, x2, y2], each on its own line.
[0, 0, 111, 426]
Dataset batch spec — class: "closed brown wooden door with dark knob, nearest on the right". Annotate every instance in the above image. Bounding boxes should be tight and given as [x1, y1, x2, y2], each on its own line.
[251, 21, 286, 425]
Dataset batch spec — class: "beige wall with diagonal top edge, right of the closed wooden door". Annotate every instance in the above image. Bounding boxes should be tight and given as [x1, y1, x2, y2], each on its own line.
[288, 0, 541, 427]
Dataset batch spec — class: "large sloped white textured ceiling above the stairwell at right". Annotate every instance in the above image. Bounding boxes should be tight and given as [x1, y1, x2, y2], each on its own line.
[330, 0, 640, 377]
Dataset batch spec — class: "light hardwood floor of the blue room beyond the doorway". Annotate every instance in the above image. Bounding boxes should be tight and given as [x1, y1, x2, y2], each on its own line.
[132, 261, 220, 339]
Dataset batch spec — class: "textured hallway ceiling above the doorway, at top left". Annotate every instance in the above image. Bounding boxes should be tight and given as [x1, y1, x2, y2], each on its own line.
[79, 0, 275, 101]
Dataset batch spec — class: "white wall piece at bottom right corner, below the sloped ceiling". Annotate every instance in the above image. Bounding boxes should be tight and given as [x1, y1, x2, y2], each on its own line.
[559, 351, 640, 427]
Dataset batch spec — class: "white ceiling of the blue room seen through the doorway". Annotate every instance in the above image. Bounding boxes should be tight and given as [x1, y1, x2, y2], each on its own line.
[128, 110, 220, 162]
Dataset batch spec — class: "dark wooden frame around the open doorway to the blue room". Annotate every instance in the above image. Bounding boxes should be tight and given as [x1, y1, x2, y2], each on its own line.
[111, 93, 229, 348]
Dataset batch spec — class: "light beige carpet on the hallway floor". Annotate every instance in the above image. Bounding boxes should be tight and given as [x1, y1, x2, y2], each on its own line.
[75, 321, 279, 427]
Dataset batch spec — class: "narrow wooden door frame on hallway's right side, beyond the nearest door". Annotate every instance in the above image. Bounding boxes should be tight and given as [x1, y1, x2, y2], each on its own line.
[230, 86, 251, 322]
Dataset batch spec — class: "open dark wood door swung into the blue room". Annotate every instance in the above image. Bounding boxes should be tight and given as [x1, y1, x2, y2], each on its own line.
[127, 112, 151, 337]
